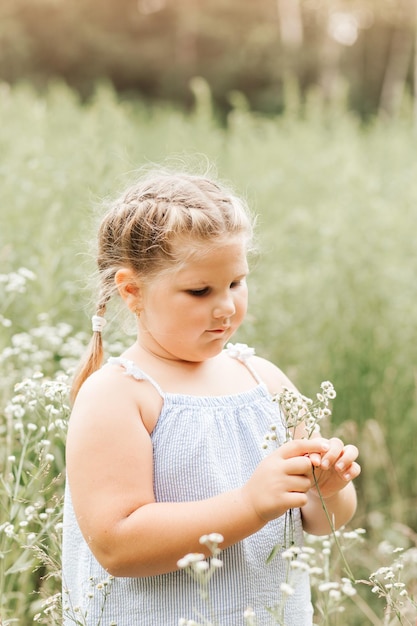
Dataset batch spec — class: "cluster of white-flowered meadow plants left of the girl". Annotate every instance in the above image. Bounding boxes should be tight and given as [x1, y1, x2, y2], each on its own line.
[0, 268, 128, 626]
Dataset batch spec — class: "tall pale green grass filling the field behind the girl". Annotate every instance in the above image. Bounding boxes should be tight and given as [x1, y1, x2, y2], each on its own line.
[0, 81, 417, 625]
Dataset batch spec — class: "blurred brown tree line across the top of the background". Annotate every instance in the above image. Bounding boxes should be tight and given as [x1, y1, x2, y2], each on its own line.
[0, 0, 417, 117]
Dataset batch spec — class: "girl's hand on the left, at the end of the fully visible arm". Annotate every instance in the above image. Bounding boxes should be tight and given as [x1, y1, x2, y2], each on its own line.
[242, 437, 335, 522]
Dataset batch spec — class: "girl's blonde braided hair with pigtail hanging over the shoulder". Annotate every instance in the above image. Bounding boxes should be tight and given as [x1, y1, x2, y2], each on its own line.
[71, 172, 253, 400]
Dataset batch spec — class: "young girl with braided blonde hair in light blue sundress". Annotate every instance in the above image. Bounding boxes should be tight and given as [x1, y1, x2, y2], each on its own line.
[63, 168, 360, 626]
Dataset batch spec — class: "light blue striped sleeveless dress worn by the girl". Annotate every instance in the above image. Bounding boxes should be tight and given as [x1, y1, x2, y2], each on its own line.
[62, 346, 313, 626]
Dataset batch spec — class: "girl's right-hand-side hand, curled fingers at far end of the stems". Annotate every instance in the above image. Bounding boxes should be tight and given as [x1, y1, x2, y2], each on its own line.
[311, 437, 361, 498]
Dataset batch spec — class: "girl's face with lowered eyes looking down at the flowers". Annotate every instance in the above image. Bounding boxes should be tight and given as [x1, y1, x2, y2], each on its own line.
[138, 237, 248, 362]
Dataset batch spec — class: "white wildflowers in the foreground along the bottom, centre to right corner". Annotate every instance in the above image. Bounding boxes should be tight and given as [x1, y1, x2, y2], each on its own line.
[178, 528, 417, 626]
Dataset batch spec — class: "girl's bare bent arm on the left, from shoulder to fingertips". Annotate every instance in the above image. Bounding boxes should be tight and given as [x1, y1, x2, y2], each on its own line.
[67, 367, 328, 576]
